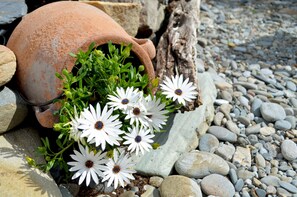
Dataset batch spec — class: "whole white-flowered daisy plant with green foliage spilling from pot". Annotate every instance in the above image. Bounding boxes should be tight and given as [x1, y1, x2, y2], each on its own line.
[27, 43, 198, 188]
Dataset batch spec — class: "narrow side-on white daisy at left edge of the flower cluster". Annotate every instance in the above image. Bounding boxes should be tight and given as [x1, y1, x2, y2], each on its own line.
[67, 106, 85, 144]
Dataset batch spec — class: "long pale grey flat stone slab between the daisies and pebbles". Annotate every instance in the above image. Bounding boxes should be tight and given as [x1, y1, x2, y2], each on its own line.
[136, 73, 216, 177]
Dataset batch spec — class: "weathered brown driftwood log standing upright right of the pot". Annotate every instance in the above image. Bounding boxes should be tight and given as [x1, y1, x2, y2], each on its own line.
[155, 0, 200, 110]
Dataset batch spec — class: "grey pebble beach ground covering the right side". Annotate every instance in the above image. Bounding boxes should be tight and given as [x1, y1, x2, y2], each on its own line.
[193, 0, 297, 197]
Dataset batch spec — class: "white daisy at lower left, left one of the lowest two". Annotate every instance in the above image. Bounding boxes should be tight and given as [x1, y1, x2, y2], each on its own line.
[67, 144, 108, 186]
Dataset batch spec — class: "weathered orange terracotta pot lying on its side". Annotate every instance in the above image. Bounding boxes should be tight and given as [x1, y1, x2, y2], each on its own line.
[7, 1, 155, 128]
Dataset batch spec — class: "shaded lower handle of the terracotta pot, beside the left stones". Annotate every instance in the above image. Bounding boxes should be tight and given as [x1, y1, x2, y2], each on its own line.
[33, 103, 61, 128]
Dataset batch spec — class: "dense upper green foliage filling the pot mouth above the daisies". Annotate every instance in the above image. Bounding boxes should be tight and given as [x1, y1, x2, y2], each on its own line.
[57, 43, 149, 123]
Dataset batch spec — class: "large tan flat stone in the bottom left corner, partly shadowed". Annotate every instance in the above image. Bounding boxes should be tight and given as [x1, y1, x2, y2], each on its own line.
[0, 128, 62, 197]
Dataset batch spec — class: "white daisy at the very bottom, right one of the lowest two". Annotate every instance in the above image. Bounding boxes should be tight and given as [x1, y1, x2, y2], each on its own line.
[102, 151, 136, 189]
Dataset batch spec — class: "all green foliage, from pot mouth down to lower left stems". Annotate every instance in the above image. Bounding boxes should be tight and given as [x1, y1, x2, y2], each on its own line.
[34, 43, 150, 173]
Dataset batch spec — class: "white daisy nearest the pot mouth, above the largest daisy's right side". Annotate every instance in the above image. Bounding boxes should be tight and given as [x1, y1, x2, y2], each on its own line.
[107, 87, 141, 112]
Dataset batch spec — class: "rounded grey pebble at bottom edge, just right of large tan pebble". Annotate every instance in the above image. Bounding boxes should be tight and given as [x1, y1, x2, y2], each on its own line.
[201, 174, 235, 197]
